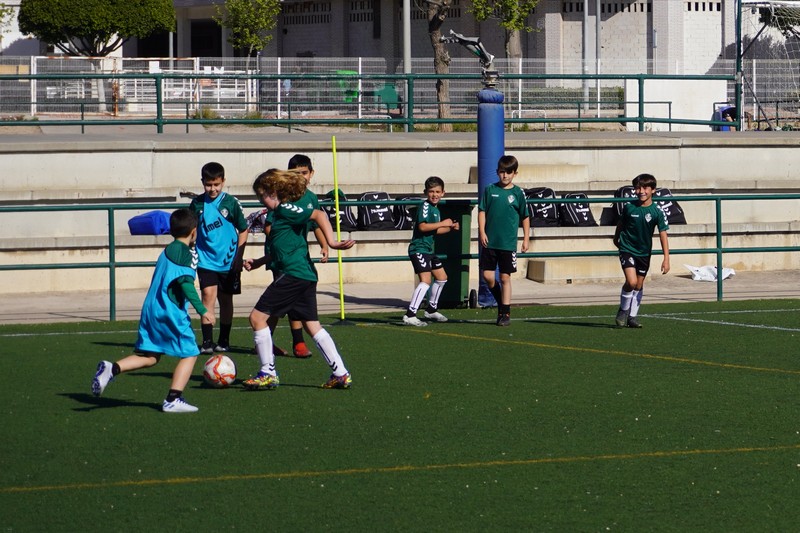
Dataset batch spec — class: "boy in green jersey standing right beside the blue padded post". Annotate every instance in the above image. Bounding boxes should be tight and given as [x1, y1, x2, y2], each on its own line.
[478, 155, 531, 326]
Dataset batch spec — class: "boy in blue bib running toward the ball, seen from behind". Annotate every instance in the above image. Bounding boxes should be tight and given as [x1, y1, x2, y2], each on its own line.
[92, 208, 214, 413]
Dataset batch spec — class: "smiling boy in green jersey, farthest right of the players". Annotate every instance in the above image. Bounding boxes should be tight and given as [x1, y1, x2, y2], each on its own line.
[614, 174, 669, 328]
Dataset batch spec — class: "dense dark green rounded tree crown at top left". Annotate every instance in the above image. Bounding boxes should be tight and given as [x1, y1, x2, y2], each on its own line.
[19, 0, 175, 56]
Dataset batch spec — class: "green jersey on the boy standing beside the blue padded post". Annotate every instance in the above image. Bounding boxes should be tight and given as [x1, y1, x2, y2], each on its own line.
[478, 183, 528, 252]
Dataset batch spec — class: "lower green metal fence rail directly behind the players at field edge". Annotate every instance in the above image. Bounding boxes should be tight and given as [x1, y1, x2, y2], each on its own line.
[0, 194, 800, 321]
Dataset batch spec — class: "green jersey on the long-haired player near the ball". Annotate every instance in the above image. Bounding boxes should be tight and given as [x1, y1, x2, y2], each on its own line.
[269, 193, 317, 281]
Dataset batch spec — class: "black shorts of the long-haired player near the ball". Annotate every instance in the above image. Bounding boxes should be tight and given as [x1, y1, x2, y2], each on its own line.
[255, 274, 319, 322]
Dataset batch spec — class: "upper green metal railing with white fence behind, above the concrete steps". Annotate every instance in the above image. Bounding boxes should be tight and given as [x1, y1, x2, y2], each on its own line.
[0, 72, 735, 133]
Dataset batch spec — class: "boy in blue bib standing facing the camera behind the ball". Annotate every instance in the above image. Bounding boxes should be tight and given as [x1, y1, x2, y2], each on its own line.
[189, 162, 248, 354]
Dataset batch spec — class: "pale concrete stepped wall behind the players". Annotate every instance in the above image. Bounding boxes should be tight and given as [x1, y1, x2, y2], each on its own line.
[0, 132, 800, 297]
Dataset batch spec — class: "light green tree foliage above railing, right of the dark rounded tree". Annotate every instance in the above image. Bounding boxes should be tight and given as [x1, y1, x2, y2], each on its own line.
[214, 0, 281, 56]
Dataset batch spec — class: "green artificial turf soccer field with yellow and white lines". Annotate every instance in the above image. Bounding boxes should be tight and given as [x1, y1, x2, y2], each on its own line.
[0, 300, 800, 532]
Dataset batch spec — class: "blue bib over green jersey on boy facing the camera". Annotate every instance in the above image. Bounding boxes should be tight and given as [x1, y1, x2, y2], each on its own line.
[189, 192, 247, 272]
